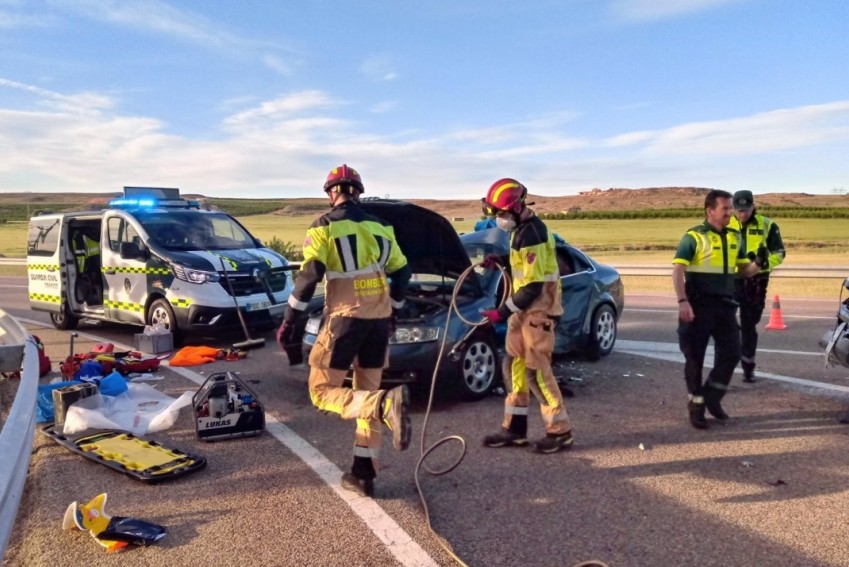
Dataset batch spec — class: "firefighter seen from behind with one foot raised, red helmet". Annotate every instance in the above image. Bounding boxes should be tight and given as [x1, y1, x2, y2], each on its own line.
[277, 165, 411, 496]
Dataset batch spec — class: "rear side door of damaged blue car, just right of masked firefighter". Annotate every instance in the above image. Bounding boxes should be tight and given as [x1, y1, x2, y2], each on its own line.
[554, 246, 596, 352]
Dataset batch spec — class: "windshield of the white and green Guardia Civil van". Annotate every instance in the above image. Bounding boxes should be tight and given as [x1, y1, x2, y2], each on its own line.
[136, 211, 258, 251]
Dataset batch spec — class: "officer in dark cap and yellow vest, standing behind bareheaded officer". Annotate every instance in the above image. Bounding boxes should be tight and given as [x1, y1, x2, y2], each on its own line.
[728, 191, 785, 382]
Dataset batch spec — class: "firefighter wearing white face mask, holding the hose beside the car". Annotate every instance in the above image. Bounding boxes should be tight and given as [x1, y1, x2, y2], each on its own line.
[482, 179, 573, 453]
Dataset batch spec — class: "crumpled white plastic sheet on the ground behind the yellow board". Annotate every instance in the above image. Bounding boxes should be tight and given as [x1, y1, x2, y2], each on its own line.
[63, 382, 192, 435]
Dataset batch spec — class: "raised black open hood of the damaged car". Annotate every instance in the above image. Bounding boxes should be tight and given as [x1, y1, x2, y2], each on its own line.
[360, 199, 471, 278]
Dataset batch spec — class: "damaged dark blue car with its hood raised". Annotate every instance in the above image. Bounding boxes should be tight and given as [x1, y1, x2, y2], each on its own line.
[304, 199, 624, 400]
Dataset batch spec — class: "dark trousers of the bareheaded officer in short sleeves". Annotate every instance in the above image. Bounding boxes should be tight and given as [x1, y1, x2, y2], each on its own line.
[678, 299, 740, 404]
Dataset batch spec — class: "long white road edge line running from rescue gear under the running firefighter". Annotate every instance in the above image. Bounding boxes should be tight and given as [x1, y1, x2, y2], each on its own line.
[18, 318, 439, 567]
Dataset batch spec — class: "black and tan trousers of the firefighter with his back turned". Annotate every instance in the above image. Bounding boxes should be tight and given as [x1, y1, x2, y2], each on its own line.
[309, 315, 389, 480]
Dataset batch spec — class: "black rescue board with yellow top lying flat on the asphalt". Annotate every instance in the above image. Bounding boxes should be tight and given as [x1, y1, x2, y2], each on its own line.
[41, 425, 206, 484]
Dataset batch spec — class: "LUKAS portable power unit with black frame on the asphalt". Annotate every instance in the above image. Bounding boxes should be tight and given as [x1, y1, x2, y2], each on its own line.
[192, 372, 265, 441]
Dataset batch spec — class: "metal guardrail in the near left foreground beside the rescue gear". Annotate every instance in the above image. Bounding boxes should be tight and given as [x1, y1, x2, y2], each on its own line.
[0, 309, 38, 560]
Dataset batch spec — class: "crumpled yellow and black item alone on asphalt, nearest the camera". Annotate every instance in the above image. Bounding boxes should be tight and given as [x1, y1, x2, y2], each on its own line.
[62, 492, 167, 552]
